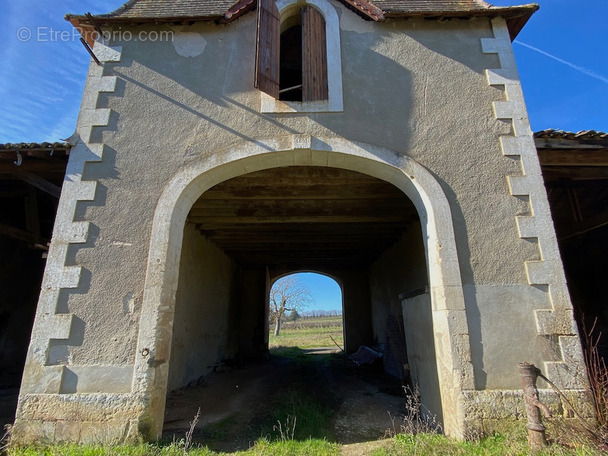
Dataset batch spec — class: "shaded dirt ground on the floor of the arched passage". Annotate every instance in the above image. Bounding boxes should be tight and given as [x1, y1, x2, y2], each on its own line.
[163, 350, 404, 452]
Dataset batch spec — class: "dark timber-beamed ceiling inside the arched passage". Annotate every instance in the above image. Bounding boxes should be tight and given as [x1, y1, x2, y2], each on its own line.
[188, 167, 418, 269]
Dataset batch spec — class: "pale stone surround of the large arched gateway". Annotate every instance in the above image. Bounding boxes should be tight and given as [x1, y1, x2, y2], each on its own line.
[132, 135, 474, 438]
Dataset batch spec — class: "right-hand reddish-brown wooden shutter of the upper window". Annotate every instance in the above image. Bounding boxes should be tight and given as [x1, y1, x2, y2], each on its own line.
[302, 6, 329, 101]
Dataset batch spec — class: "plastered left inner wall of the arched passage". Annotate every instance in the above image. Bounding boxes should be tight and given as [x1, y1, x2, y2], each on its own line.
[168, 223, 240, 390]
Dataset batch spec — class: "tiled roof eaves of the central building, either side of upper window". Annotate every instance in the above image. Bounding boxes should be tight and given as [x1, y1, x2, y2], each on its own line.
[66, 0, 539, 39]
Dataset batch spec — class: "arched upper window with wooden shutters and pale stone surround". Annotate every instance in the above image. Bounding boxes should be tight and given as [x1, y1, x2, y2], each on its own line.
[255, 0, 343, 112]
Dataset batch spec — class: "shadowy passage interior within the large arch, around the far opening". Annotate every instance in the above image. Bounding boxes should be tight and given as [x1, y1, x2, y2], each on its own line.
[164, 166, 441, 449]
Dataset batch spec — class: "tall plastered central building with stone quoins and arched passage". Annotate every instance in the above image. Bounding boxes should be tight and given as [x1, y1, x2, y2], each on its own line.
[13, 0, 585, 442]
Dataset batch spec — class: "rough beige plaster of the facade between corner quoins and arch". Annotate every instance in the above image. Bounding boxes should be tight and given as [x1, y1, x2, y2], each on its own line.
[52, 13, 538, 370]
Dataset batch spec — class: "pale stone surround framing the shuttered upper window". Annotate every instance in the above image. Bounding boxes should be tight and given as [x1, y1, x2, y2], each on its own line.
[256, 0, 344, 113]
